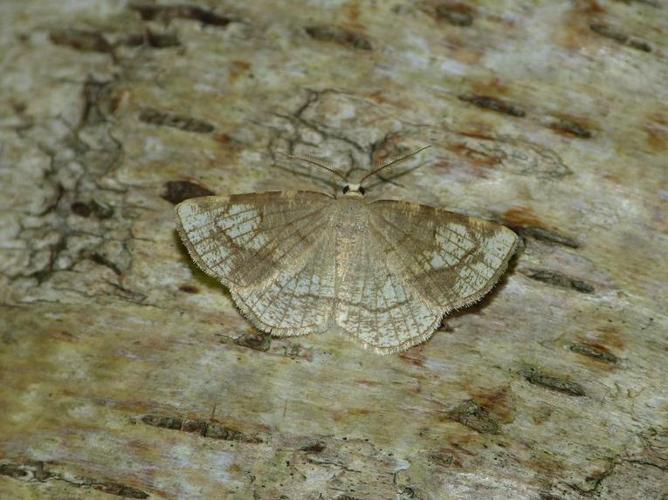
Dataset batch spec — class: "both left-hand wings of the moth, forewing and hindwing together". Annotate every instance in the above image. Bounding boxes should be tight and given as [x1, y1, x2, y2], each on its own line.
[176, 191, 335, 335]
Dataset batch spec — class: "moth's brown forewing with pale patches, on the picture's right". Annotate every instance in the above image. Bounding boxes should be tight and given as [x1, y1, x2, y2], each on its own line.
[371, 200, 517, 308]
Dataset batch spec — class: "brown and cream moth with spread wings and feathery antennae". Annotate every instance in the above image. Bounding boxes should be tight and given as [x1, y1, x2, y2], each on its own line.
[176, 148, 518, 353]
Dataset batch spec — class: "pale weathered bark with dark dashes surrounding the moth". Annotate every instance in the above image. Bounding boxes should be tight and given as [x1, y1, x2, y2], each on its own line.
[0, 0, 668, 499]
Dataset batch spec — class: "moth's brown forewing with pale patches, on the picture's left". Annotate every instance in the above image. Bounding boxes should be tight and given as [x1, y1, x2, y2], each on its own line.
[176, 191, 331, 288]
